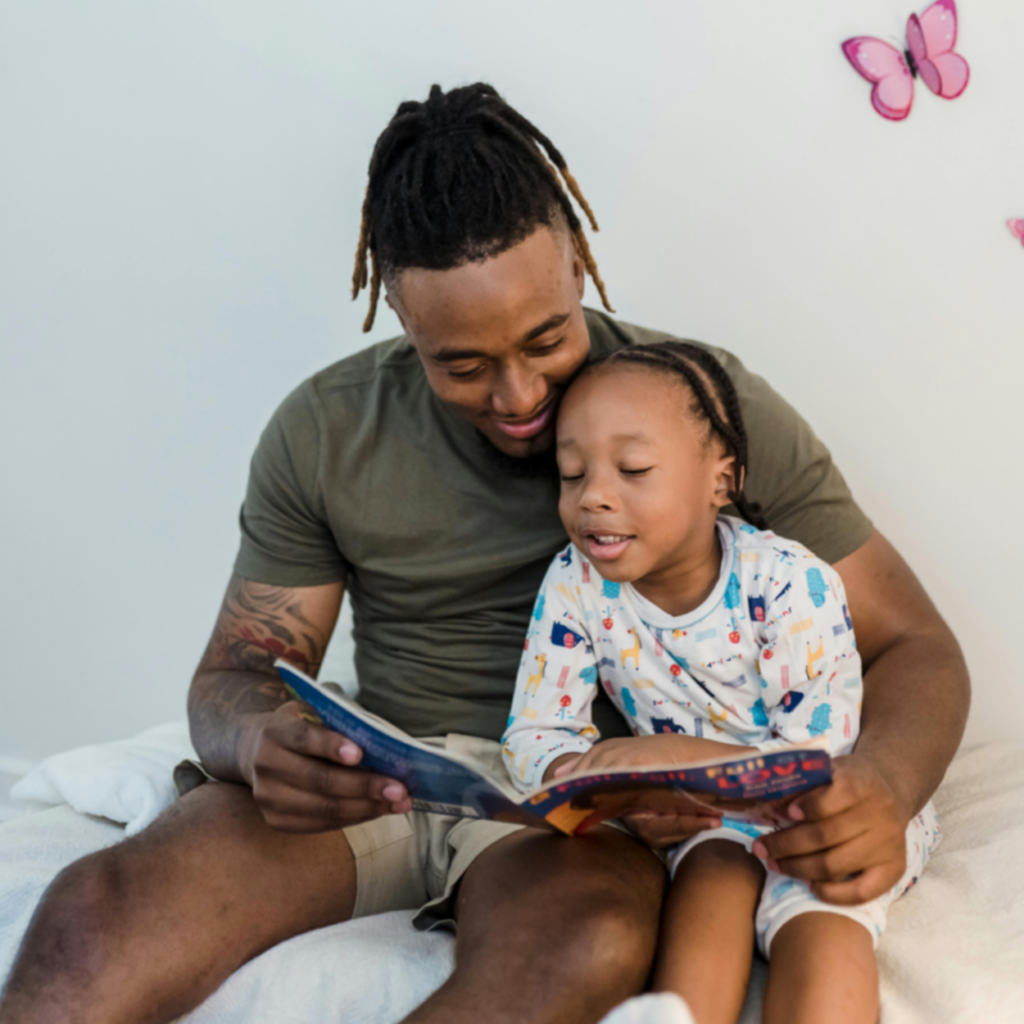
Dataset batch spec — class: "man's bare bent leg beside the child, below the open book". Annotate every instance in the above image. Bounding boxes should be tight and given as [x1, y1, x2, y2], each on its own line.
[407, 827, 666, 1024]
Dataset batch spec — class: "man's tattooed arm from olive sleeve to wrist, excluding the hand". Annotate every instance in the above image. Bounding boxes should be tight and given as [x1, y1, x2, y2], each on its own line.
[188, 577, 340, 781]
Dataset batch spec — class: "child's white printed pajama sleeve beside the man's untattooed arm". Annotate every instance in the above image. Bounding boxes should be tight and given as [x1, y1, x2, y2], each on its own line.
[756, 552, 863, 757]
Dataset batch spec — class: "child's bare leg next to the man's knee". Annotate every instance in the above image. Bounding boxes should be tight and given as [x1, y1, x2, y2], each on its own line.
[652, 840, 764, 1024]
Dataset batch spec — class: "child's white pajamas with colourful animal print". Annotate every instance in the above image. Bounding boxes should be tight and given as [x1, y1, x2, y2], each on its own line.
[503, 516, 939, 952]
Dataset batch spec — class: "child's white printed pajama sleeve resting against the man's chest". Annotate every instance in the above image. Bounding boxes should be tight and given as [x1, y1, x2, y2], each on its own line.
[502, 546, 601, 793]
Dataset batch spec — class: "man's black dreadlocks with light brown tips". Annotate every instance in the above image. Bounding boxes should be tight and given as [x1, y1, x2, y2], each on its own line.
[352, 82, 614, 331]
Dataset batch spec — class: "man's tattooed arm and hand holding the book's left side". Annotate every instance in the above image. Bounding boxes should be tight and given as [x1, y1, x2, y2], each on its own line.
[188, 575, 411, 831]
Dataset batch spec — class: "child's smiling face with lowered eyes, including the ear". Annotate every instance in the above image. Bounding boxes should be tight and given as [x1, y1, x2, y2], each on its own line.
[557, 365, 734, 583]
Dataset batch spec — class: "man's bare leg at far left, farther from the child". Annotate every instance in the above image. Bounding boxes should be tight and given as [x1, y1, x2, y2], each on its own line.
[0, 783, 355, 1024]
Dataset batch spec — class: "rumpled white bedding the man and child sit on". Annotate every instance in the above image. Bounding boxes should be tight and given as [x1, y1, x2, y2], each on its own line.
[0, 726, 1024, 1024]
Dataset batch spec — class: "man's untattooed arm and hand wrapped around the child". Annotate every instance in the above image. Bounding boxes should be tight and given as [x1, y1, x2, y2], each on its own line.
[762, 531, 971, 903]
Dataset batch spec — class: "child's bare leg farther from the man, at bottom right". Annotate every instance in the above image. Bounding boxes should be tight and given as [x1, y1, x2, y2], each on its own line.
[762, 911, 879, 1024]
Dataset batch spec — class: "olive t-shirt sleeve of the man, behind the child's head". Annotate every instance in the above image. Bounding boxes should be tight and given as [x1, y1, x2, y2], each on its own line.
[712, 349, 874, 565]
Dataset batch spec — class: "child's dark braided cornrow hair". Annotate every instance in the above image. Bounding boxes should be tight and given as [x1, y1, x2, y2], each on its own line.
[577, 341, 768, 529]
